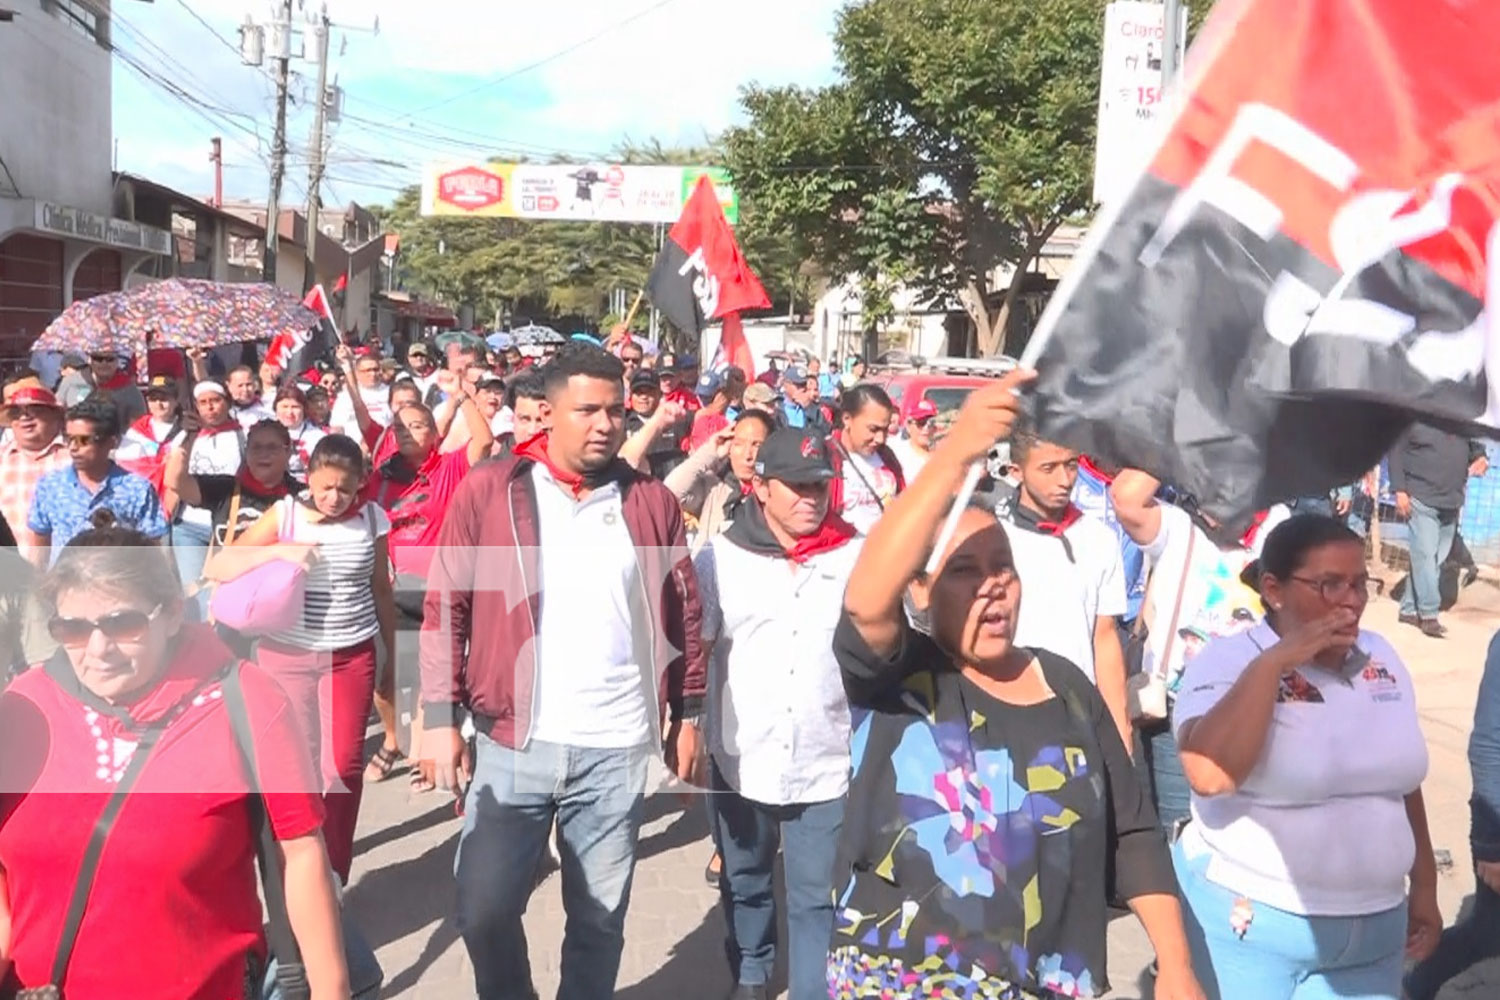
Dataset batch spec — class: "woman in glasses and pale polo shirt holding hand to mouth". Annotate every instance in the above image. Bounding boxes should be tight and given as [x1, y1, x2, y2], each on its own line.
[1173, 514, 1443, 1000]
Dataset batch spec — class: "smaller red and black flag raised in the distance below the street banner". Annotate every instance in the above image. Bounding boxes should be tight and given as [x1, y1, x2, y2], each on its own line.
[647, 177, 771, 339]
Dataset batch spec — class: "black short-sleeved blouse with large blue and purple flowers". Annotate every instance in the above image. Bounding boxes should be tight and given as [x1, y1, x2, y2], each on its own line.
[828, 616, 1176, 1000]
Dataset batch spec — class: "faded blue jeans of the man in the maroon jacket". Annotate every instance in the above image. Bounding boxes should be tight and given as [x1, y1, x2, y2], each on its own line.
[455, 733, 650, 1000]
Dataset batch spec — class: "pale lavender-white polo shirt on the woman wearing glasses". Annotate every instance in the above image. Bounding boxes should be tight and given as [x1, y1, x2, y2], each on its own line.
[1172, 622, 1428, 919]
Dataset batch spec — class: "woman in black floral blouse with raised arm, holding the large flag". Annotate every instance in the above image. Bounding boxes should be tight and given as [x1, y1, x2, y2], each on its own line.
[828, 373, 1203, 1000]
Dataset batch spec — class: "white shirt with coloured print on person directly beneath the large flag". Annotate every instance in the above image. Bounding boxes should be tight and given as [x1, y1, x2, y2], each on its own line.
[1142, 504, 1290, 691]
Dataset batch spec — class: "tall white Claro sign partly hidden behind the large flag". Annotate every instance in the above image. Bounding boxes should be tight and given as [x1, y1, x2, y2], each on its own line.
[1094, 0, 1188, 202]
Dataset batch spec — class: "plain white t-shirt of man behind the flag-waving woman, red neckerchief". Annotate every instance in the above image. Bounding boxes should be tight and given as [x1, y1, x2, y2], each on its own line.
[1005, 516, 1125, 681]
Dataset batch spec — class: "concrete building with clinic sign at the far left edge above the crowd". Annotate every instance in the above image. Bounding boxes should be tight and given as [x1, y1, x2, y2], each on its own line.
[0, 0, 173, 360]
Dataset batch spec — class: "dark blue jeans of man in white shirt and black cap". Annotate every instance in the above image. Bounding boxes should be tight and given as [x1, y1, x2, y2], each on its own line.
[713, 766, 845, 1000]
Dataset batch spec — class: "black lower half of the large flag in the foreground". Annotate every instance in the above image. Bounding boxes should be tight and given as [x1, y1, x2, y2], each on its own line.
[1032, 175, 1484, 535]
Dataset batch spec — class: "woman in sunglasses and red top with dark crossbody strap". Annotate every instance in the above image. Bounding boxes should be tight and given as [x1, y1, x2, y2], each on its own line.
[0, 511, 350, 1000]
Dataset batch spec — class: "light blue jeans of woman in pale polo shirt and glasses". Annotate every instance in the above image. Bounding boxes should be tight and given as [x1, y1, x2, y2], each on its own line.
[1172, 838, 1407, 1000]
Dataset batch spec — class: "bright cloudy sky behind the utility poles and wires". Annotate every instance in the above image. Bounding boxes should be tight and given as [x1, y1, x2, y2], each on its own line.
[116, 0, 840, 198]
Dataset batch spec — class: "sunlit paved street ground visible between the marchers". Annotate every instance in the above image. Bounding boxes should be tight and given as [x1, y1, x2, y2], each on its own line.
[348, 582, 1500, 1000]
